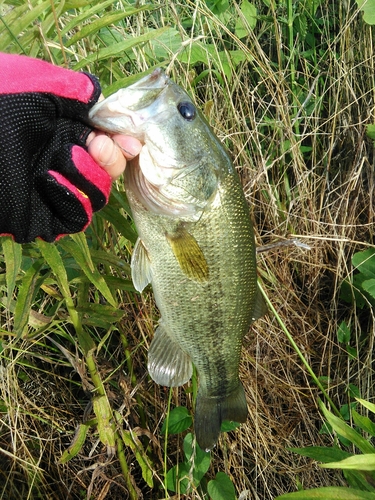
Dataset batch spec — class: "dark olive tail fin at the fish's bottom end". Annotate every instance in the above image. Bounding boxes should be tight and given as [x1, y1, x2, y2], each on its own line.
[194, 383, 247, 451]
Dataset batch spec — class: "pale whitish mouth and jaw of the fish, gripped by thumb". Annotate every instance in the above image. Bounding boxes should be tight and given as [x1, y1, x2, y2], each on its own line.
[89, 68, 169, 140]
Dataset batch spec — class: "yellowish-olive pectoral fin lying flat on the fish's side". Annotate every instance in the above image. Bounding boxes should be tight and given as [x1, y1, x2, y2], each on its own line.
[167, 229, 209, 282]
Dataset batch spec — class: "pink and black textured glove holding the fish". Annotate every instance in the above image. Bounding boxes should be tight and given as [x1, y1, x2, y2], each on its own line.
[0, 54, 111, 243]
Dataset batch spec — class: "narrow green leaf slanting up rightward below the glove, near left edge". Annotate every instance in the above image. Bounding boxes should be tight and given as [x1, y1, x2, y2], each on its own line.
[13, 259, 46, 339]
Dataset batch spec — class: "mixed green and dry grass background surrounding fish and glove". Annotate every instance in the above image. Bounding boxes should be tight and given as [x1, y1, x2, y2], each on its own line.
[0, 0, 375, 500]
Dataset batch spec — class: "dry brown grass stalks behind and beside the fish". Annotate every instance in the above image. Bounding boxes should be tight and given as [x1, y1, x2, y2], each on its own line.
[0, 2, 375, 500]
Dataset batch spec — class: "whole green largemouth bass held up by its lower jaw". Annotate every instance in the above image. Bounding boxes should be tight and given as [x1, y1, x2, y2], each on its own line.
[89, 69, 265, 451]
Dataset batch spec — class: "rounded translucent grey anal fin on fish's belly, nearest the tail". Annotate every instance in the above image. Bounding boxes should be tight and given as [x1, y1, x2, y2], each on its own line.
[147, 324, 193, 387]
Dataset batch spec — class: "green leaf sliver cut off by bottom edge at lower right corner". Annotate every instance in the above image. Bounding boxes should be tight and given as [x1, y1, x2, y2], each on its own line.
[275, 486, 375, 500]
